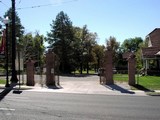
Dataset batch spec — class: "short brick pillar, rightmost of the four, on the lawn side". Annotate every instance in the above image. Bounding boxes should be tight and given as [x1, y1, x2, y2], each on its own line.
[128, 54, 136, 85]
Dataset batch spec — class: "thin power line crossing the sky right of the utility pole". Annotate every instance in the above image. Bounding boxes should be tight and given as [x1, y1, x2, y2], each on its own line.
[17, 0, 78, 10]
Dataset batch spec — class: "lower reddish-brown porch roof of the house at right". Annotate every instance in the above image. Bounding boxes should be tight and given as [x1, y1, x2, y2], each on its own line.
[142, 47, 160, 58]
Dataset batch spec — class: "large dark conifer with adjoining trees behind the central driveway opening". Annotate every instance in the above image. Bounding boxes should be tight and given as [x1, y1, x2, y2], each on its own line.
[46, 11, 97, 73]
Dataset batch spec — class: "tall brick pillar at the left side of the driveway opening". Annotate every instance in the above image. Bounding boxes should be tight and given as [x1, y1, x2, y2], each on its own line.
[46, 49, 55, 86]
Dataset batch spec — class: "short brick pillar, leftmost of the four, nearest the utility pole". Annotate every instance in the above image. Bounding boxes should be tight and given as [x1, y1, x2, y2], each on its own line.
[27, 59, 35, 86]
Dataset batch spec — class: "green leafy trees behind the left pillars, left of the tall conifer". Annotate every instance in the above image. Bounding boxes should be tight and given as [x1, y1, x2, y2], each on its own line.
[22, 33, 45, 67]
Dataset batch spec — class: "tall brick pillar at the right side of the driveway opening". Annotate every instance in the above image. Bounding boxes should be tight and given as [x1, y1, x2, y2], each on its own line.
[104, 49, 114, 85]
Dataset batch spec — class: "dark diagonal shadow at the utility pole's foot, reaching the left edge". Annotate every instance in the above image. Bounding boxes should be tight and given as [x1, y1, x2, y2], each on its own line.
[0, 84, 16, 101]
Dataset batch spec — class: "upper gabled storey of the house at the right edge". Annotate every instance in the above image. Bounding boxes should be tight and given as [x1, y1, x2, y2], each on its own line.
[147, 28, 160, 47]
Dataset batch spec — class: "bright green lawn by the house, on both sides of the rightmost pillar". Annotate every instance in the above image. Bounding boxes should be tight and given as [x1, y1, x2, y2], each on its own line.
[113, 74, 160, 90]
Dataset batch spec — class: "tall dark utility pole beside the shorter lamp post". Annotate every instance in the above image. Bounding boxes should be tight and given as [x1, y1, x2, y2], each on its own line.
[11, 0, 18, 83]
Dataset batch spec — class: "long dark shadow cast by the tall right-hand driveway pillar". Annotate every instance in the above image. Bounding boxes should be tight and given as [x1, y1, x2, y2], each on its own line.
[104, 84, 135, 94]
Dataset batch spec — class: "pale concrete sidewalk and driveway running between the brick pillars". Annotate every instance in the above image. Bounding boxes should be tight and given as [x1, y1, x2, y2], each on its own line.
[0, 75, 151, 96]
